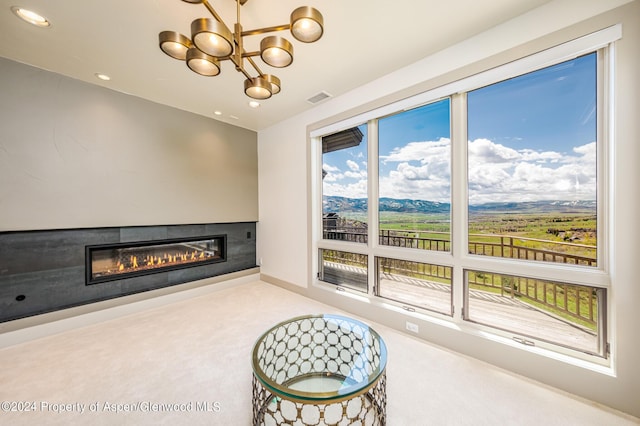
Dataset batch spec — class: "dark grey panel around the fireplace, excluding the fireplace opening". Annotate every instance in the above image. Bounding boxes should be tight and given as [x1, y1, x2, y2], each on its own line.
[0, 222, 256, 322]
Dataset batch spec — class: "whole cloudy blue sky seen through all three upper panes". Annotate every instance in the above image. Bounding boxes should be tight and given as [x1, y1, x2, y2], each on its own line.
[323, 54, 596, 204]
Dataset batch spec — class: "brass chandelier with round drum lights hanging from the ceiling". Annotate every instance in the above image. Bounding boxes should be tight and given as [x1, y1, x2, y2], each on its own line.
[158, 0, 324, 99]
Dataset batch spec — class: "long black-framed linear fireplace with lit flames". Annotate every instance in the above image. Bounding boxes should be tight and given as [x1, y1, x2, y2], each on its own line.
[85, 235, 227, 285]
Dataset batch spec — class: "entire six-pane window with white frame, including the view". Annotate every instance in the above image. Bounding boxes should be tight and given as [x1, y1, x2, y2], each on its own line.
[312, 30, 619, 363]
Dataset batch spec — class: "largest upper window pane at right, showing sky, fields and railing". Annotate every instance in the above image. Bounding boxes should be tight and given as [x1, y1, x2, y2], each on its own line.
[467, 53, 598, 266]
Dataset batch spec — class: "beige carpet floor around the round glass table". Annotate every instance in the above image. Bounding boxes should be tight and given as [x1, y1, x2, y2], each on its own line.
[0, 281, 640, 426]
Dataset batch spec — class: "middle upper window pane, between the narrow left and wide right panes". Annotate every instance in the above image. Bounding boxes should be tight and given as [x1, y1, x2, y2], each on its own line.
[378, 98, 451, 251]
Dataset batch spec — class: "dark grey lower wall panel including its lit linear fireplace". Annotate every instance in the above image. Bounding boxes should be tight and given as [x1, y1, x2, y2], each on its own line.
[0, 222, 256, 322]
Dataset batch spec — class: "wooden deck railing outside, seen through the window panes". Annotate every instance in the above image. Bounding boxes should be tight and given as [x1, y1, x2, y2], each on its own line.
[324, 229, 601, 329]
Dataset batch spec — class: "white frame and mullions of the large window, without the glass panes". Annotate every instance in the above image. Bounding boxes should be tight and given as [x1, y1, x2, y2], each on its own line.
[310, 24, 622, 366]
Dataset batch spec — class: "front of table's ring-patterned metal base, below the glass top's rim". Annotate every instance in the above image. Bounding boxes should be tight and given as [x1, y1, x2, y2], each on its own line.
[253, 373, 387, 426]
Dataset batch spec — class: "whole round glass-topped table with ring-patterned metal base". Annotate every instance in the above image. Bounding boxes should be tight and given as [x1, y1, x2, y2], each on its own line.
[252, 314, 387, 426]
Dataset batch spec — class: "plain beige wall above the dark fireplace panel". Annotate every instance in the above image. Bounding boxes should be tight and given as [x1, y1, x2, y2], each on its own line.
[0, 58, 258, 231]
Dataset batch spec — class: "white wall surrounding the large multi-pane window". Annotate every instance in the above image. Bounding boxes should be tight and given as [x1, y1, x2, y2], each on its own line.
[258, 0, 640, 416]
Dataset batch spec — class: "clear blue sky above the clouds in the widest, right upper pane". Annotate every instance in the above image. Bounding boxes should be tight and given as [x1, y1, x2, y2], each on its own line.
[467, 54, 596, 153]
